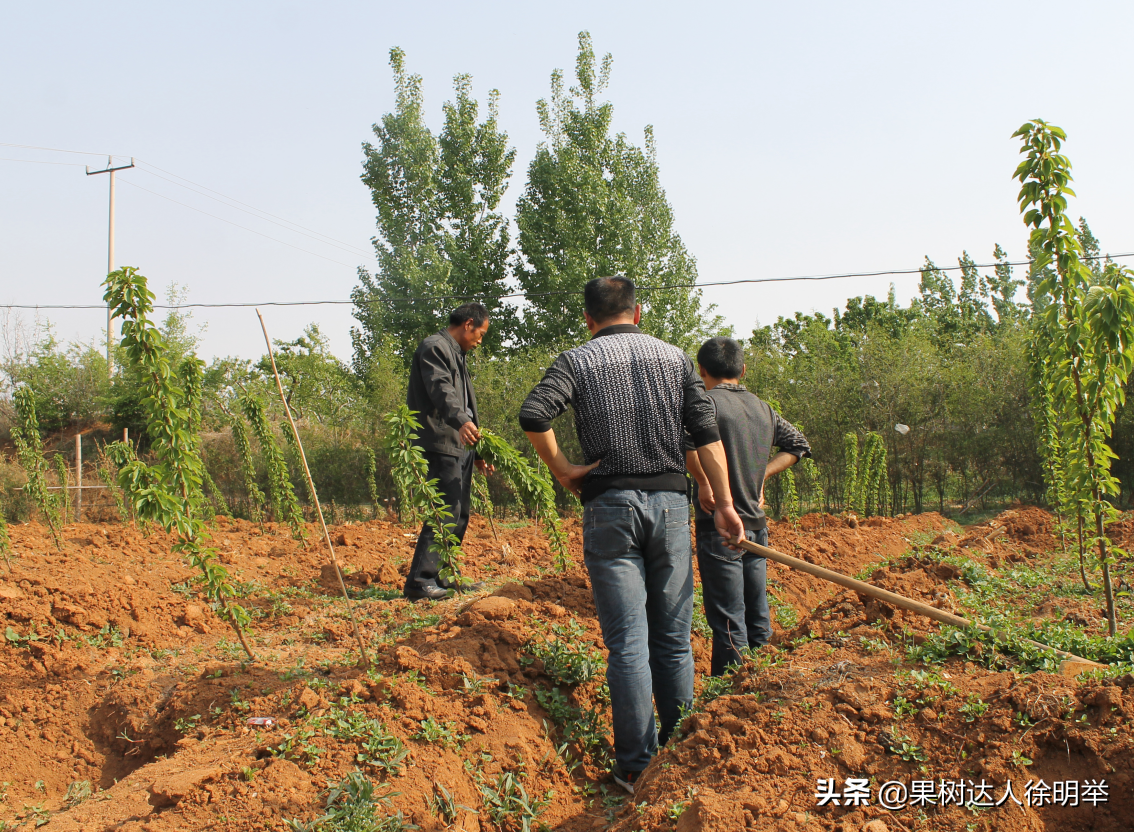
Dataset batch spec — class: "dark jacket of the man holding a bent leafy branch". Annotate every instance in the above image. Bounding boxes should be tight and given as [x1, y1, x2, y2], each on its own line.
[406, 330, 480, 457]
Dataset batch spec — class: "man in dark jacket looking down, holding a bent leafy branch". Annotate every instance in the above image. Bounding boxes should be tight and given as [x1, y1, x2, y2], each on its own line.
[403, 304, 492, 601]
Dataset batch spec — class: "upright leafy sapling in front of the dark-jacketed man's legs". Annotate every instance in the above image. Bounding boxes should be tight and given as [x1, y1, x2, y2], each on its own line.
[382, 405, 464, 584]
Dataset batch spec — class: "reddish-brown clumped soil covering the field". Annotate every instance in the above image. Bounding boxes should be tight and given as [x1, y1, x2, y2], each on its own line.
[0, 508, 1134, 832]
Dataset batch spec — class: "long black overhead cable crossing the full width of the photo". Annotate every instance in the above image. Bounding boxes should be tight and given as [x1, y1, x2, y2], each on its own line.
[8, 252, 1134, 309]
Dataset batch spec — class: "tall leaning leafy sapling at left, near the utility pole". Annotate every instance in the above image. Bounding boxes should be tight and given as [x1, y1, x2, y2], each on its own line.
[103, 266, 254, 659]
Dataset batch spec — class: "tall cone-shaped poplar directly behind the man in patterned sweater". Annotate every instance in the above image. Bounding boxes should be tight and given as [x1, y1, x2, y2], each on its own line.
[516, 32, 721, 350]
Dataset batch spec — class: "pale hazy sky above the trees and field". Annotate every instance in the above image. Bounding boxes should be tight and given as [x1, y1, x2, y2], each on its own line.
[0, 0, 1134, 359]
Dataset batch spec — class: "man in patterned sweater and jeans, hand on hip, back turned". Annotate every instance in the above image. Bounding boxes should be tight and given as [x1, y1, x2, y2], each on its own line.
[519, 277, 744, 793]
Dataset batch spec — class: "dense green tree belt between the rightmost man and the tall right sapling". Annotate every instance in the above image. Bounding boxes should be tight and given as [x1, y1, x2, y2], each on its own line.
[745, 260, 1042, 513]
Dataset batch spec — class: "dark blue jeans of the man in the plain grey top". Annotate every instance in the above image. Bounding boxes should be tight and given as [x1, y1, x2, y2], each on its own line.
[697, 523, 772, 676]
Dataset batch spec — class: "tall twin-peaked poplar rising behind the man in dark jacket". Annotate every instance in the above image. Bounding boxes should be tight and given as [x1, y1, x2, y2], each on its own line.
[350, 48, 516, 377]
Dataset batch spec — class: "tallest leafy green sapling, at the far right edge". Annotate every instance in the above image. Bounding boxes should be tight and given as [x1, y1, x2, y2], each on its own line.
[1013, 119, 1134, 635]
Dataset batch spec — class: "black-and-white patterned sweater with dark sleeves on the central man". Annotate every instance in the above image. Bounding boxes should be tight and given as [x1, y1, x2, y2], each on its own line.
[519, 324, 720, 502]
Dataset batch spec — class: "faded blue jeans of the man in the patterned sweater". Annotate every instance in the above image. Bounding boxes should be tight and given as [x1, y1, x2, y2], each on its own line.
[583, 491, 693, 772]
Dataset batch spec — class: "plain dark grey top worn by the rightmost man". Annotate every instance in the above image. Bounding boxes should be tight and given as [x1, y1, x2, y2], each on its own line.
[685, 383, 811, 529]
